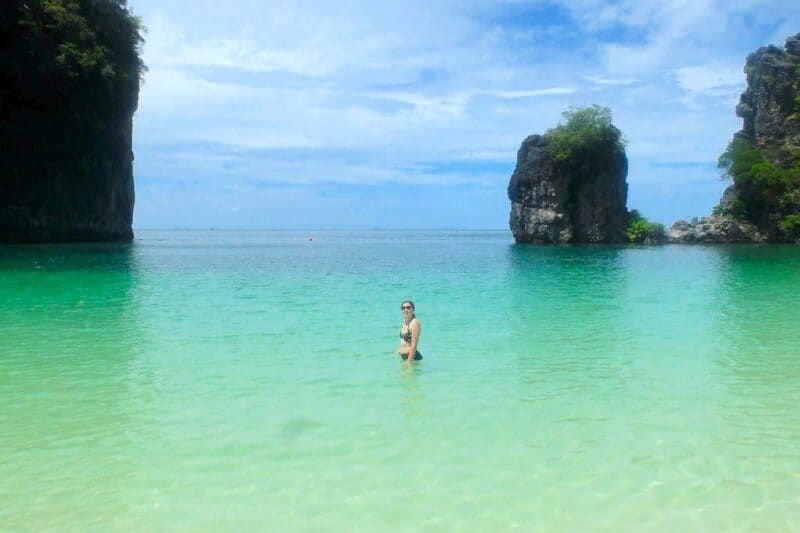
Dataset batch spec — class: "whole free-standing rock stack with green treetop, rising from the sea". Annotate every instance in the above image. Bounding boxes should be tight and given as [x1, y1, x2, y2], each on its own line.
[508, 107, 628, 244]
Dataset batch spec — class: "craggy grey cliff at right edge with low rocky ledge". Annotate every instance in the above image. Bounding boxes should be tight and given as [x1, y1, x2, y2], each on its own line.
[667, 33, 800, 242]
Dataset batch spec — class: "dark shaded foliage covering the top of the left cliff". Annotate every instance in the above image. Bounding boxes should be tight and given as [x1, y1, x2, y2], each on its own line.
[0, 0, 145, 114]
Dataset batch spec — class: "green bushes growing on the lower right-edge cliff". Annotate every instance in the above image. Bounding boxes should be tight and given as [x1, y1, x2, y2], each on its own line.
[715, 137, 800, 240]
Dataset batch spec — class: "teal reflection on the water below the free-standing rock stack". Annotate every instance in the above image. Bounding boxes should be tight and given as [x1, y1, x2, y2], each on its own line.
[504, 244, 630, 399]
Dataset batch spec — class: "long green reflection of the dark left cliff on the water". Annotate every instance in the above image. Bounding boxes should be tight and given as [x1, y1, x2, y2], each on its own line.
[0, 244, 144, 529]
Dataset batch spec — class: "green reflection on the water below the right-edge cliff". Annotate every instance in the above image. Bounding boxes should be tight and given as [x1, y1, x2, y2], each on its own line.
[694, 244, 800, 508]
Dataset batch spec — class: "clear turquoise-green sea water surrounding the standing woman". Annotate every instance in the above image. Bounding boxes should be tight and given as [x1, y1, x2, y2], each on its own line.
[0, 231, 800, 531]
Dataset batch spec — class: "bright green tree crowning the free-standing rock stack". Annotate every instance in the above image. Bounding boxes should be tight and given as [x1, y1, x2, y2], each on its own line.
[546, 104, 625, 161]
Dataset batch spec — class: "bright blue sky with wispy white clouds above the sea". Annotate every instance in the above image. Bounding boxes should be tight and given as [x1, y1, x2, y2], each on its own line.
[129, 0, 800, 228]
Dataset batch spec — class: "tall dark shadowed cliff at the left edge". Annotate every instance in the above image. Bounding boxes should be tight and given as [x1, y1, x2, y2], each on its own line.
[0, 0, 143, 243]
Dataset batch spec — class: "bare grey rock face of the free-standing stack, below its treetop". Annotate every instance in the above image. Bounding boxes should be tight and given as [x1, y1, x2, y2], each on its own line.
[508, 135, 628, 244]
